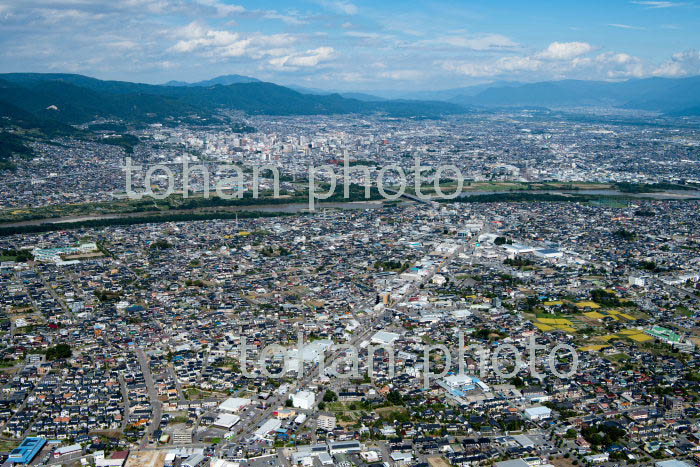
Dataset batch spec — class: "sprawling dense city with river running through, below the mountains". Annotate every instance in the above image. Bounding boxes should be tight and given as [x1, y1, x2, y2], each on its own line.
[0, 109, 700, 467]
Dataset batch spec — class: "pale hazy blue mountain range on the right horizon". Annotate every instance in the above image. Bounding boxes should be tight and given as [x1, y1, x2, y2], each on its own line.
[449, 76, 700, 116]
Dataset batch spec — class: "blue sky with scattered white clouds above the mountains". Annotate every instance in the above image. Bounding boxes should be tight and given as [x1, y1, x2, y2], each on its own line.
[0, 0, 700, 91]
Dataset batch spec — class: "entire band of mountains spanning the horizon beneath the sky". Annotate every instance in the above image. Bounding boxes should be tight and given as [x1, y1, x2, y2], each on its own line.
[0, 73, 700, 134]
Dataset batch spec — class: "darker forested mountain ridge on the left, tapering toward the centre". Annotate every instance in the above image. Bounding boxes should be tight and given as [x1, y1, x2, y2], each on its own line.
[0, 73, 466, 124]
